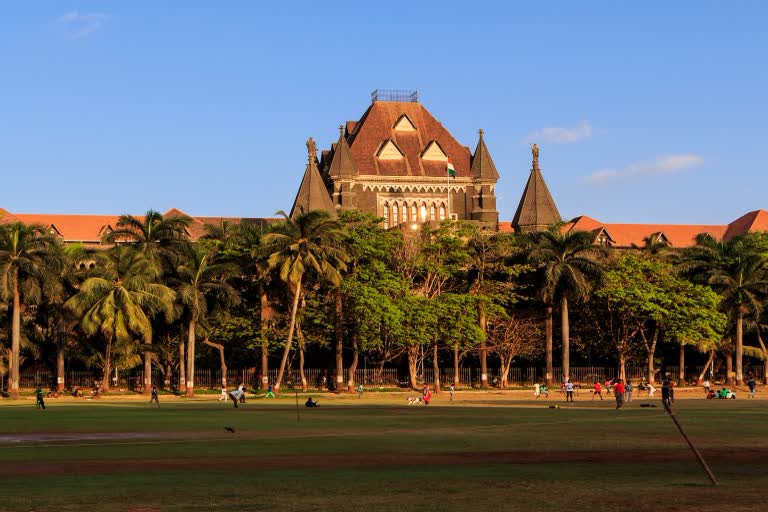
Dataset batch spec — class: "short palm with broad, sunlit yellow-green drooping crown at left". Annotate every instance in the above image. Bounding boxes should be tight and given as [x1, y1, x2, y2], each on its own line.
[65, 246, 175, 390]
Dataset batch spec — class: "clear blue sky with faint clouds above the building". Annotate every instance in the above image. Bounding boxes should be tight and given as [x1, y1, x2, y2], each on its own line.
[0, 0, 768, 224]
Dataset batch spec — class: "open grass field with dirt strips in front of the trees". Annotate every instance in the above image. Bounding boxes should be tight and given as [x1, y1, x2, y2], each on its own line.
[0, 392, 768, 512]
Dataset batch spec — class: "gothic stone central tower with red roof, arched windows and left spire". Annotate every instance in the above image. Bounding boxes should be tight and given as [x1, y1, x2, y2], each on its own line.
[291, 91, 499, 230]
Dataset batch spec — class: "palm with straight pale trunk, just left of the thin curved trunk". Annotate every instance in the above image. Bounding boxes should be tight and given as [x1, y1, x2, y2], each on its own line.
[175, 247, 240, 397]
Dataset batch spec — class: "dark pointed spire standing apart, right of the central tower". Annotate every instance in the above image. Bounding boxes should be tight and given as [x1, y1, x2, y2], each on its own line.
[512, 144, 562, 232]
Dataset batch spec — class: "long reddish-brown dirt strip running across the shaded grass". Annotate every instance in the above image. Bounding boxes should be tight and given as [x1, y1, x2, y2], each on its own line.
[0, 449, 768, 478]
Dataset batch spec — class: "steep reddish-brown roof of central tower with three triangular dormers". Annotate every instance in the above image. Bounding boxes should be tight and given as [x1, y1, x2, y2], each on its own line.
[346, 101, 471, 177]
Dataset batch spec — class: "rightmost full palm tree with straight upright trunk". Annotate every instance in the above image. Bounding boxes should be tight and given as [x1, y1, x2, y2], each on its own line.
[681, 235, 768, 386]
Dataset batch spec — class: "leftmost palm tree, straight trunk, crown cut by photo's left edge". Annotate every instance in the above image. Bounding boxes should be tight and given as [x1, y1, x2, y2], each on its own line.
[0, 222, 63, 399]
